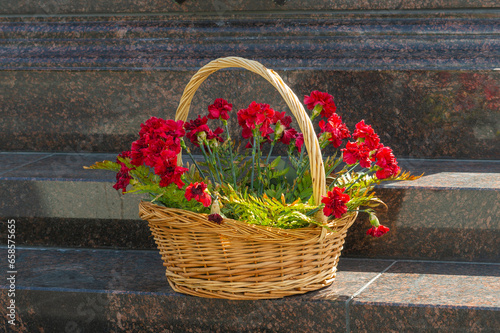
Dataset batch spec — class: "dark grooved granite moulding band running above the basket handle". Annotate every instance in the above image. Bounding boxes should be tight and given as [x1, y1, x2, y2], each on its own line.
[0, 10, 500, 71]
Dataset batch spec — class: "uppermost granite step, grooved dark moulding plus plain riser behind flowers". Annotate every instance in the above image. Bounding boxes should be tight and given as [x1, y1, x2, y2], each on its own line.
[0, 11, 500, 159]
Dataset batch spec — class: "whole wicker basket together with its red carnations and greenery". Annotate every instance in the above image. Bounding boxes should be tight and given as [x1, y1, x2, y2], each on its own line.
[86, 57, 422, 299]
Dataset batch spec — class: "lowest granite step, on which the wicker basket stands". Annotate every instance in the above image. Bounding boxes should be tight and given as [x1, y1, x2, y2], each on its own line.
[0, 247, 500, 332]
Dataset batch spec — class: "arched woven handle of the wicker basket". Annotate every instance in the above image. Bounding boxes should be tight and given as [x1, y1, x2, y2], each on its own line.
[175, 57, 326, 220]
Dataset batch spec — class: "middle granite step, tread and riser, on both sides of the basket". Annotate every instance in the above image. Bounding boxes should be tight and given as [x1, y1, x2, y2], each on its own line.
[0, 152, 500, 262]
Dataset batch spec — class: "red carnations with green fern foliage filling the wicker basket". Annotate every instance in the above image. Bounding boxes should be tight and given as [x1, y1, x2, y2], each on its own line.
[90, 91, 415, 237]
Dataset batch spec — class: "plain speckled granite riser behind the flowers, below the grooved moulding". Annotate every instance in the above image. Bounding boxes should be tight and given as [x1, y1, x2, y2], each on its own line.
[0, 67, 500, 160]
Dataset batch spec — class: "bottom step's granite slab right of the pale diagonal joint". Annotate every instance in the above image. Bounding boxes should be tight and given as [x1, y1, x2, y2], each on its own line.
[350, 262, 500, 332]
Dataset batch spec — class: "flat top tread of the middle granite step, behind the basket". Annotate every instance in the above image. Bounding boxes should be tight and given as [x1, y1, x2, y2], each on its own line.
[0, 152, 500, 184]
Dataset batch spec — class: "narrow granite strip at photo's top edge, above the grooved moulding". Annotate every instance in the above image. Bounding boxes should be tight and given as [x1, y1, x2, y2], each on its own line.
[0, 0, 498, 15]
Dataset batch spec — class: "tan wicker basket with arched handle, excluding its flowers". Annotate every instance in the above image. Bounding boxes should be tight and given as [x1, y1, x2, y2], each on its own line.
[139, 57, 357, 300]
